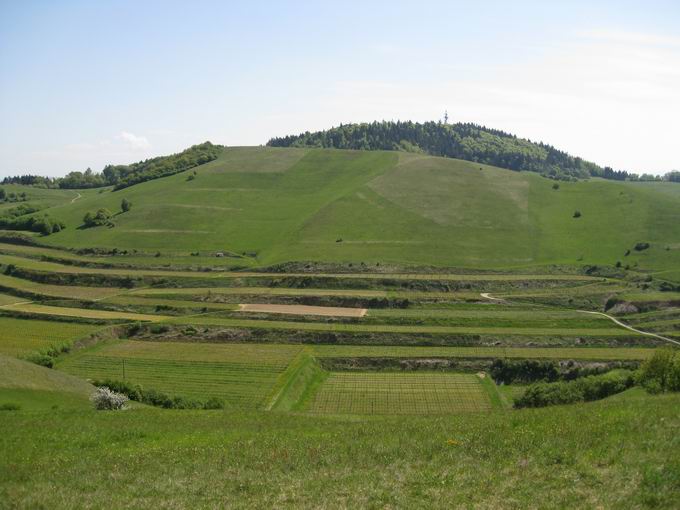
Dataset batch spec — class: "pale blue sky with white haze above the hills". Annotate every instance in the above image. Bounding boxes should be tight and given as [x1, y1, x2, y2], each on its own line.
[0, 0, 680, 176]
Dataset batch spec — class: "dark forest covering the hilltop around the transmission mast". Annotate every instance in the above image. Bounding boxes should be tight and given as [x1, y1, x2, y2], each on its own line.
[267, 121, 680, 181]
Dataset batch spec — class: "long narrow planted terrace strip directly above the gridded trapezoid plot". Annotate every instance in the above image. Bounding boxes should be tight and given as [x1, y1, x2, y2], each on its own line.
[312, 345, 654, 361]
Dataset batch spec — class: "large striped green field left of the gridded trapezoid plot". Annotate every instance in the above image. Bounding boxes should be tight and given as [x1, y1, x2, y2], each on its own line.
[58, 341, 301, 408]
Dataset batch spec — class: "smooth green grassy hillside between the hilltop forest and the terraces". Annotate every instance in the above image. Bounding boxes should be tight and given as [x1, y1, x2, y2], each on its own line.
[10, 148, 680, 278]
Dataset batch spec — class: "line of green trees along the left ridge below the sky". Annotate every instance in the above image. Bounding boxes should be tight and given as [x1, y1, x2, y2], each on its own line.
[2, 142, 224, 190]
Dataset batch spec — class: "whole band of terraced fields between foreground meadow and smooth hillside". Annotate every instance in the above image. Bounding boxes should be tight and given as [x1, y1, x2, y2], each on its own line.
[0, 245, 679, 415]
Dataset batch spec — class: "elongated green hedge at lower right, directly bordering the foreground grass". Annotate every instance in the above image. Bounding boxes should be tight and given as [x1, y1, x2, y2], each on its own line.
[515, 370, 635, 408]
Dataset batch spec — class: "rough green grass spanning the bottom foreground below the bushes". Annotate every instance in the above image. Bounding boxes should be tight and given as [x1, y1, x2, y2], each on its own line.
[0, 395, 680, 508]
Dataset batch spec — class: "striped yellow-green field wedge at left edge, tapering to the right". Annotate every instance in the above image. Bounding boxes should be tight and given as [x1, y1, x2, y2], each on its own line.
[0, 317, 101, 356]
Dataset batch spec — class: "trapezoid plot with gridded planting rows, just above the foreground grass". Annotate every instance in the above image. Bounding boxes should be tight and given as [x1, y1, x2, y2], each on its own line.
[309, 372, 492, 414]
